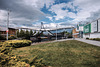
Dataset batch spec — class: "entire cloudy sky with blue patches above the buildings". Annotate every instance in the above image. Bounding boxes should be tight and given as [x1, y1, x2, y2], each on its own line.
[0, 0, 100, 29]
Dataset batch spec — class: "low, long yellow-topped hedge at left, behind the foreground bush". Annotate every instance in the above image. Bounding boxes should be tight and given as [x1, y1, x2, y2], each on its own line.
[4, 40, 32, 48]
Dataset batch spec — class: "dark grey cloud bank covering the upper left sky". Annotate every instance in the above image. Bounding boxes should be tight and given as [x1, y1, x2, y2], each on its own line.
[0, 0, 54, 26]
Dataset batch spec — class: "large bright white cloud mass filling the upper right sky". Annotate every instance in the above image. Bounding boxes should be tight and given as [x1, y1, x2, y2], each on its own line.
[49, 0, 100, 23]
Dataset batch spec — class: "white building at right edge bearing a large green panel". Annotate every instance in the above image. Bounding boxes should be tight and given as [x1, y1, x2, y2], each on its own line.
[83, 19, 100, 38]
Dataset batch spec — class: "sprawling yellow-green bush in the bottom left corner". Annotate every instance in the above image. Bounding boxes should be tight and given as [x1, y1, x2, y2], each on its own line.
[0, 40, 44, 67]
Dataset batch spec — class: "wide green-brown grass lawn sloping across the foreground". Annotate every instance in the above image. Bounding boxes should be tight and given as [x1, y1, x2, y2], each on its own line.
[12, 40, 100, 67]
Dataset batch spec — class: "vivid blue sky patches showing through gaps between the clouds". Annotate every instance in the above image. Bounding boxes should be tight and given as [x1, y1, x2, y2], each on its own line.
[40, 0, 74, 23]
